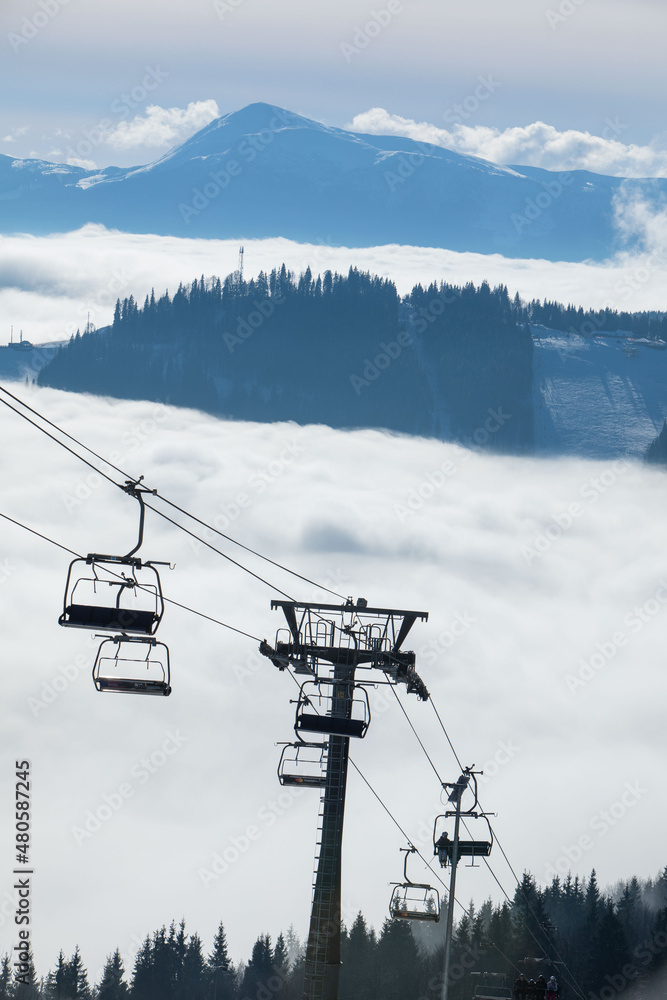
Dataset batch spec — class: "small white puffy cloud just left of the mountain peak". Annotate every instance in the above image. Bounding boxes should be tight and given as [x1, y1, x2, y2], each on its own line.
[104, 100, 220, 149]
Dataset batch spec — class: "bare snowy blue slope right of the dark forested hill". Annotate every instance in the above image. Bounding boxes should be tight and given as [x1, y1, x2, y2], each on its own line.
[531, 325, 667, 459]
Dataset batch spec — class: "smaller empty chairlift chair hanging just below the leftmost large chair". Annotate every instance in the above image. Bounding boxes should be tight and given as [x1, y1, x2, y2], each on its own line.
[93, 635, 171, 696]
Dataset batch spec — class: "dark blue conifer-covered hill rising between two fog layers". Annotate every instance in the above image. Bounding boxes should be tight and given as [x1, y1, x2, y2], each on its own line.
[39, 266, 532, 450]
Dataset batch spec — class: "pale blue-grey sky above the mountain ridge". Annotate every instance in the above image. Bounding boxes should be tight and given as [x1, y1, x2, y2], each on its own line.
[0, 0, 667, 172]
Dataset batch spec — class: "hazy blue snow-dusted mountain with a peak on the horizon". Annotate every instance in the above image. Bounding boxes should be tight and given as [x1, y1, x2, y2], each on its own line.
[0, 103, 667, 261]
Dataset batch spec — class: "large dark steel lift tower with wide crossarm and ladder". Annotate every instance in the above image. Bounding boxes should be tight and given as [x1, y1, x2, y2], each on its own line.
[260, 598, 429, 1000]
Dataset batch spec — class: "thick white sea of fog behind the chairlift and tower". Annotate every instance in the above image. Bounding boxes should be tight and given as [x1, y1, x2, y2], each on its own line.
[0, 389, 667, 978]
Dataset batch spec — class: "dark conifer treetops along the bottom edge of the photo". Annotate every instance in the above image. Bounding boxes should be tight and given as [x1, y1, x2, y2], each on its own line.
[7, 868, 667, 1000]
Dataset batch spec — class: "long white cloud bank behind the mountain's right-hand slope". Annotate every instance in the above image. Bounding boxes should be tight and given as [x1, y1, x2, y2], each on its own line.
[346, 105, 667, 177]
